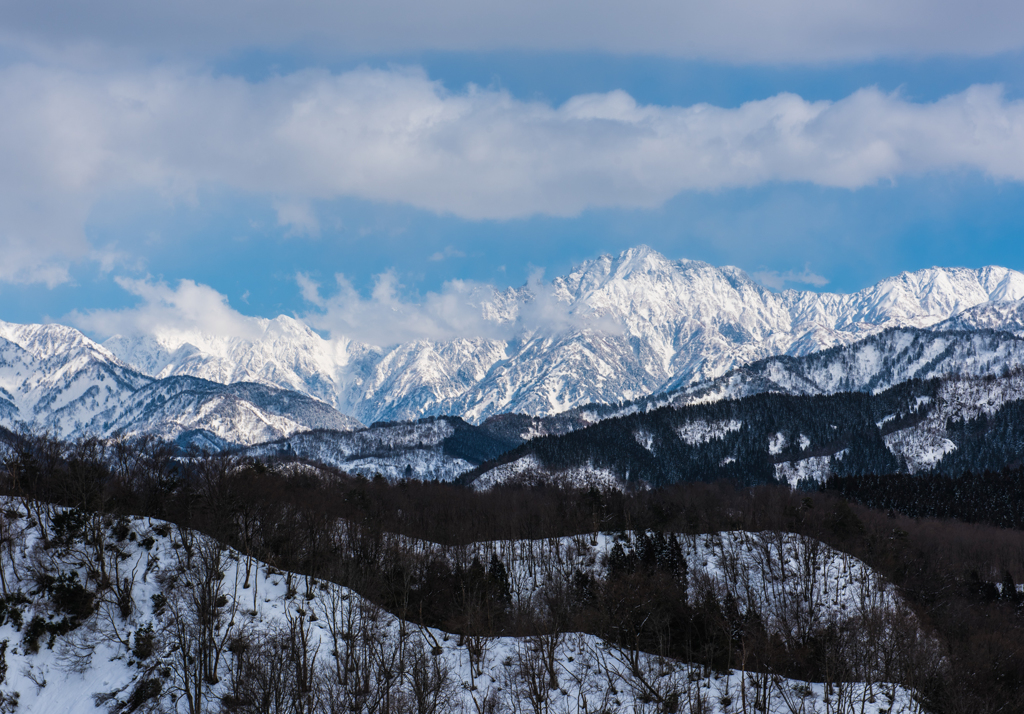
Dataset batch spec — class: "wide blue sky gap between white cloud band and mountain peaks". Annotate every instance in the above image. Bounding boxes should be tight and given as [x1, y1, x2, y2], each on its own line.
[6, 174, 1024, 322]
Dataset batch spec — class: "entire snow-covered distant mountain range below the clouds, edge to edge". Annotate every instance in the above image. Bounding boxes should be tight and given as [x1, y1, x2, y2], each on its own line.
[0, 246, 1024, 467]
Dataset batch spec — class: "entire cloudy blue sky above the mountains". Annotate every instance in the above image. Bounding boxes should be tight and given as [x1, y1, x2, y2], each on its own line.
[0, 0, 1024, 337]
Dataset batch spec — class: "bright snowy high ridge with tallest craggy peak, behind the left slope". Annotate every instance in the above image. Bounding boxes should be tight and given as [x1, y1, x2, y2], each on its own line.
[104, 246, 1024, 423]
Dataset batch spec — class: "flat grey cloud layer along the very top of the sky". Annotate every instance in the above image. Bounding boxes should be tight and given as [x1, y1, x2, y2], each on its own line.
[6, 0, 1024, 62]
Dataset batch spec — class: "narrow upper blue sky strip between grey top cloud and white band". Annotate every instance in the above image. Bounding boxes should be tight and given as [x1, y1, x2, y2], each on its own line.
[214, 51, 1024, 108]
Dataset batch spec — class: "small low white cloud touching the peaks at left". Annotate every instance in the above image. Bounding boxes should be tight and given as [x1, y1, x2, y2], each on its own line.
[61, 278, 266, 340]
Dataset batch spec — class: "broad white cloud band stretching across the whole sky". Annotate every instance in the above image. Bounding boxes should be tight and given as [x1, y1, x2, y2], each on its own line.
[6, 66, 1024, 284]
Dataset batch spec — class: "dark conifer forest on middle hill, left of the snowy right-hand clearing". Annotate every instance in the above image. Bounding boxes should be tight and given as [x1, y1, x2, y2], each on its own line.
[465, 380, 938, 486]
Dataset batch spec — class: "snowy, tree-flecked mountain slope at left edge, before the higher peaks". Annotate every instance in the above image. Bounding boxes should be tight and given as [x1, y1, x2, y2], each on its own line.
[0, 323, 361, 445]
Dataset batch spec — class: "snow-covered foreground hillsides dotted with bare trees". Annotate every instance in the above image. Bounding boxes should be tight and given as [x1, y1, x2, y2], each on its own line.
[0, 501, 920, 714]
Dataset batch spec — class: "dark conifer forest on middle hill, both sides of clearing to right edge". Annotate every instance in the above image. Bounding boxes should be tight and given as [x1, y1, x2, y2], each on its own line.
[463, 380, 1024, 488]
